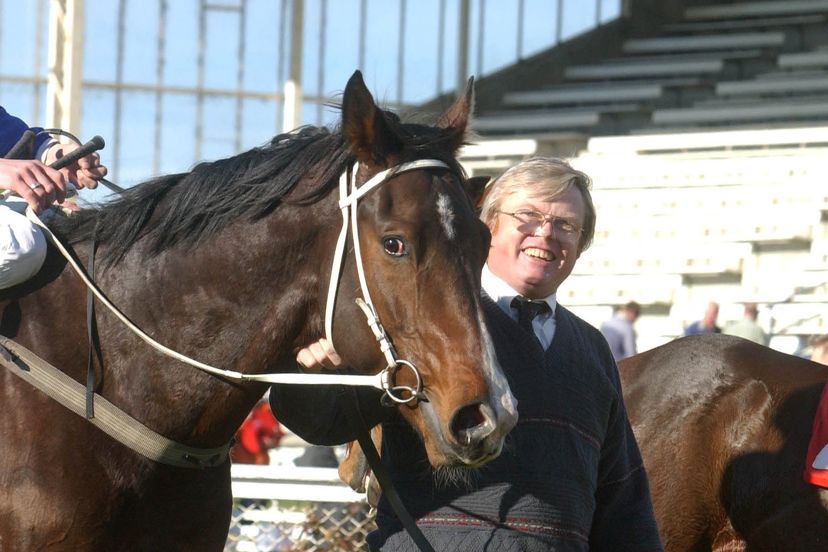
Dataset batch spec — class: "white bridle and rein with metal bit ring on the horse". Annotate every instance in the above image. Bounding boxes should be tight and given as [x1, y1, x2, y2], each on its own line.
[26, 159, 450, 404]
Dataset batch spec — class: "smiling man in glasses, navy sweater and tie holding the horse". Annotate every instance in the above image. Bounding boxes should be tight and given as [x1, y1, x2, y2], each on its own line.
[270, 157, 662, 552]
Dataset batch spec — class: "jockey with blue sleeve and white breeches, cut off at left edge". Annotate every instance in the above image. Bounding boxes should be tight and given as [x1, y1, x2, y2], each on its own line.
[0, 106, 107, 289]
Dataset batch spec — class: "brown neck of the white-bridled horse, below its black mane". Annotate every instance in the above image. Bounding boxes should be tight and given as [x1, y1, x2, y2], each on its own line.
[68, 209, 335, 446]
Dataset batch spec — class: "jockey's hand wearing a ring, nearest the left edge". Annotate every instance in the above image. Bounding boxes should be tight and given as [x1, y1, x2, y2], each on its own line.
[0, 159, 67, 214]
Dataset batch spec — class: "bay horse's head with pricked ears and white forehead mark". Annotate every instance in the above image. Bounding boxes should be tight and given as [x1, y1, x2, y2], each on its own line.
[324, 72, 516, 466]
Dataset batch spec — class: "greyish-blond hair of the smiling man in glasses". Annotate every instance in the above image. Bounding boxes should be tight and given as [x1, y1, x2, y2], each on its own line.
[480, 157, 596, 254]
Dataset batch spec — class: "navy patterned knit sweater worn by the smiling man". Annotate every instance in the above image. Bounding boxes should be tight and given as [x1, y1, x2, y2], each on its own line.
[271, 297, 661, 552]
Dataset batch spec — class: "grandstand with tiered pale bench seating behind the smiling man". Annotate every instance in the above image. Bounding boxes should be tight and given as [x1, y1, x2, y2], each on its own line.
[452, 0, 828, 353]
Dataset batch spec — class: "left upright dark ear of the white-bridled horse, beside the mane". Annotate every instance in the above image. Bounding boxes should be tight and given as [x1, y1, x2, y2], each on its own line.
[342, 71, 402, 165]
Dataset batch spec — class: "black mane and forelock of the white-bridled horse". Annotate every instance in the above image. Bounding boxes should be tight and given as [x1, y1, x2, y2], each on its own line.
[51, 112, 463, 265]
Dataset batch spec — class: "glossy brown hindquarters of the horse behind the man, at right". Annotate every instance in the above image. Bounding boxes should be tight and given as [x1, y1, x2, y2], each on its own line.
[618, 335, 828, 552]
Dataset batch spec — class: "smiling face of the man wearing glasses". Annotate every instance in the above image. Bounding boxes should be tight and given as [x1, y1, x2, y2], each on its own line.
[488, 187, 586, 299]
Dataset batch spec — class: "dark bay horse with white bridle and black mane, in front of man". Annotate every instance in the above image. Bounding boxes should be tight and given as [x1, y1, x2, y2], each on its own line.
[0, 72, 516, 552]
